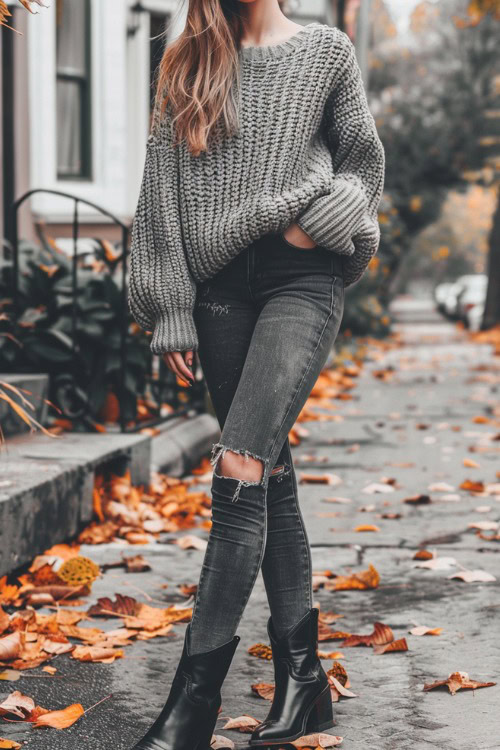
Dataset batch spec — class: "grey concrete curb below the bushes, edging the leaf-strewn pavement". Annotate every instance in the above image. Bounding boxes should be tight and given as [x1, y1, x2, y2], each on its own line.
[0, 414, 219, 577]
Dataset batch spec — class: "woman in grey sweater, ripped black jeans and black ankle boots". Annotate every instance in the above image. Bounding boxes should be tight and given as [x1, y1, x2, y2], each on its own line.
[129, 0, 384, 750]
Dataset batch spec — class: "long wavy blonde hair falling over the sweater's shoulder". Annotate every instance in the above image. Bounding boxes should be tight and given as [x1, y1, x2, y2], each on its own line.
[152, 0, 243, 156]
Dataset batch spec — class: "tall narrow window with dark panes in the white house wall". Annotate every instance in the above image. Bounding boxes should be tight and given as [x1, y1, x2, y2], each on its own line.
[56, 0, 92, 179]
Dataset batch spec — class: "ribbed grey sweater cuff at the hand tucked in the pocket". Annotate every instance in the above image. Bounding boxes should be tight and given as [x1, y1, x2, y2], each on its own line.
[296, 177, 367, 255]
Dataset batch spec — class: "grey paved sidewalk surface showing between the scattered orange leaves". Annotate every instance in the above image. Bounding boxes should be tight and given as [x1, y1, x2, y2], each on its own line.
[0, 303, 500, 750]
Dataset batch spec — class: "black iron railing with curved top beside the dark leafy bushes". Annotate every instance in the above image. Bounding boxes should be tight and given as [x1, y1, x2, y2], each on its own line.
[5, 188, 205, 432]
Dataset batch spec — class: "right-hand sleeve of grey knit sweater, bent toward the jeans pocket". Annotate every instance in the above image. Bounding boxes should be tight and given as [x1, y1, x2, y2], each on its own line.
[297, 32, 385, 286]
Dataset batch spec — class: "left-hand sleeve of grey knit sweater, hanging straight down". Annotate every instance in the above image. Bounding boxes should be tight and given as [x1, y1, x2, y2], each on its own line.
[128, 126, 198, 354]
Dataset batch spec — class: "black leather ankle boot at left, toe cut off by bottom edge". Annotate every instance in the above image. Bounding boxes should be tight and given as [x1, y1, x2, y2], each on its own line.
[134, 625, 240, 750]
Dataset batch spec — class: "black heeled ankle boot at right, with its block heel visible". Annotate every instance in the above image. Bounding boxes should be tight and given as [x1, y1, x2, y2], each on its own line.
[250, 608, 334, 745]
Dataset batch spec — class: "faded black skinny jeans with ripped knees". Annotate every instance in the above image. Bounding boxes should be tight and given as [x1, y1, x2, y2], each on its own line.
[190, 234, 344, 653]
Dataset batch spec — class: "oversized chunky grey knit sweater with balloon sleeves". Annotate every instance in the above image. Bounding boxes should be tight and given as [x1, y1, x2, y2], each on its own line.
[128, 23, 384, 354]
